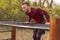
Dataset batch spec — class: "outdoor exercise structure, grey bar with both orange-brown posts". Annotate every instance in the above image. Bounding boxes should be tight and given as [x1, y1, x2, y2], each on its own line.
[0, 20, 60, 40]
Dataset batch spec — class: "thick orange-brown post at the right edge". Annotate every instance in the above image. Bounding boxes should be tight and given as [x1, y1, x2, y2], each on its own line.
[50, 19, 60, 40]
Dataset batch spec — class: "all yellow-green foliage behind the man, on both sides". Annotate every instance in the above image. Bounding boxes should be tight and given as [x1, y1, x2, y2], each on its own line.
[0, 0, 60, 22]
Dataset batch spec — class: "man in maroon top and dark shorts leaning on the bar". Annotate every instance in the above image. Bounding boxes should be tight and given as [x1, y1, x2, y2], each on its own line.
[22, 2, 50, 40]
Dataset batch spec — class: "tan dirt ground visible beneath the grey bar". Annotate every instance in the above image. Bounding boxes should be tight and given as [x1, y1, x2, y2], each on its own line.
[0, 27, 49, 40]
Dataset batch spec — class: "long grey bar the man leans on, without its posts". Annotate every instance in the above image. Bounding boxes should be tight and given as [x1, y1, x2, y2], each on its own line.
[0, 22, 50, 30]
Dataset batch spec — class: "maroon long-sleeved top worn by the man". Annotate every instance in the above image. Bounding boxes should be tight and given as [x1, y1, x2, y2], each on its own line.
[27, 8, 50, 24]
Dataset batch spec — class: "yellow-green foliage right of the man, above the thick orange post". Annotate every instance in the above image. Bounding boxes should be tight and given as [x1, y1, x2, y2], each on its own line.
[44, 7, 60, 18]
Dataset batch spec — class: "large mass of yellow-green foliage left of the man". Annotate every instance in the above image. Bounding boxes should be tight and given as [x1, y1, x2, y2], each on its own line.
[0, 0, 26, 21]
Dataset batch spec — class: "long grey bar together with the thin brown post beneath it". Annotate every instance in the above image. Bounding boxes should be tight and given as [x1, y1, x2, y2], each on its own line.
[0, 22, 50, 40]
